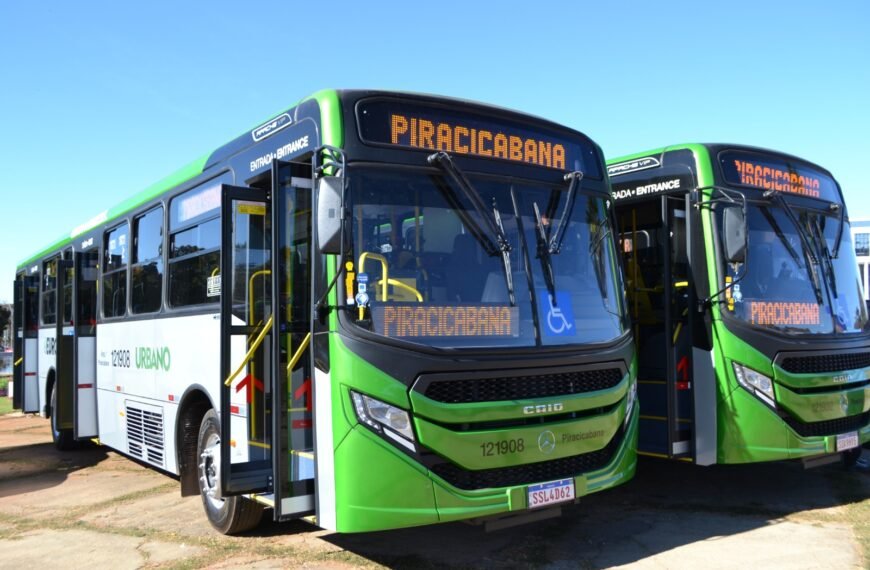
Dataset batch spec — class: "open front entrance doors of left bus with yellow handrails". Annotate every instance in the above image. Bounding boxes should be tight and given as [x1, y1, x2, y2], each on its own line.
[220, 156, 314, 519]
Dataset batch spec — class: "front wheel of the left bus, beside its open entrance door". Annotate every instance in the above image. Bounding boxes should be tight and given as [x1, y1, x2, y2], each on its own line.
[196, 410, 263, 534]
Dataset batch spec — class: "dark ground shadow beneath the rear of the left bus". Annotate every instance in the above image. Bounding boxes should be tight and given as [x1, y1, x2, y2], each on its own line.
[0, 443, 109, 498]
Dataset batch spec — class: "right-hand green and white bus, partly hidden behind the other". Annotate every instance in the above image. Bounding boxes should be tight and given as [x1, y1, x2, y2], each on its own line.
[608, 144, 870, 465]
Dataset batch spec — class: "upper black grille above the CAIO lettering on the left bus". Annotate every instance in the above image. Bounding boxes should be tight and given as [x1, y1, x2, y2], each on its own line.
[423, 368, 623, 404]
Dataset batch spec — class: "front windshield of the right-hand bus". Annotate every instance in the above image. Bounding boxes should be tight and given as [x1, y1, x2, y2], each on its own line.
[725, 203, 868, 334]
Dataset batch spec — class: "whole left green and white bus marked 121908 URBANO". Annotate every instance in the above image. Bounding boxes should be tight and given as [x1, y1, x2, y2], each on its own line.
[15, 90, 637, 533]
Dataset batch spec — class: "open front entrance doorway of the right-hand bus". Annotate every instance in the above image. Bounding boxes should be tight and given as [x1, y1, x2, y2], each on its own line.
[619, 194, 694, 458]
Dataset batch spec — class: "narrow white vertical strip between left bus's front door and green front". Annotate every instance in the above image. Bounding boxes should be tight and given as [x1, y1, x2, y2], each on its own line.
[314, 368, 336, 530]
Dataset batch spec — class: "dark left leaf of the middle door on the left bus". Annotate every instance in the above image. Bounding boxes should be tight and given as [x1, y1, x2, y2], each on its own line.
[51, 258, 75, 430]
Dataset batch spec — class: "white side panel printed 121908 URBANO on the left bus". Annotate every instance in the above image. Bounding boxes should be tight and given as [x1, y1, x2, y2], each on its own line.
[96, 313, 220, 474]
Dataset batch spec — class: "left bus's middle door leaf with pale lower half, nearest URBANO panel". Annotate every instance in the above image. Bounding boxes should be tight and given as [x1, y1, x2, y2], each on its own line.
[72, 248, 99, 439]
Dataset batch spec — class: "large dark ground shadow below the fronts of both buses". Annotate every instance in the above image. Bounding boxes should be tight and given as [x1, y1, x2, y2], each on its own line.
[324, 452, 870, 568]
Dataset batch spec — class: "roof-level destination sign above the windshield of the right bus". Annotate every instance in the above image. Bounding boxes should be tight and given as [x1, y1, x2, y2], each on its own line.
[719, 151, 840, 202]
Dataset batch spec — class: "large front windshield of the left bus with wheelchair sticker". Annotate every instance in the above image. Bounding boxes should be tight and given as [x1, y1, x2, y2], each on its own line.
[346, 167, 624, 348]
